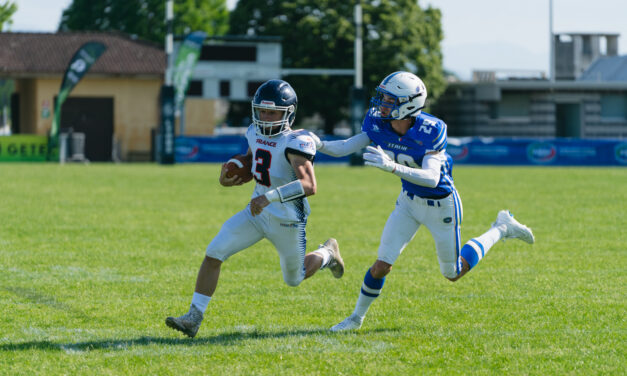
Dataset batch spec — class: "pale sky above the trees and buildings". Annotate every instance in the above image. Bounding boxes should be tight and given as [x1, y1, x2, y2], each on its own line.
[11, 0, 627, 79]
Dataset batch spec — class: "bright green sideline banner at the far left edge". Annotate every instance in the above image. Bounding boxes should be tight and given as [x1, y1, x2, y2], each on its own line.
[0, 134, 48, 162]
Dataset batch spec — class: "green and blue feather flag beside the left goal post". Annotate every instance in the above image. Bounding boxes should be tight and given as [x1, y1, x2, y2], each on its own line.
[174, 31, 207, 116]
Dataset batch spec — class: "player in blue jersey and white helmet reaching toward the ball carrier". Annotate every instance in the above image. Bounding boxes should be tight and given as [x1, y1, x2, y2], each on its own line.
[314, 72, 534, 331]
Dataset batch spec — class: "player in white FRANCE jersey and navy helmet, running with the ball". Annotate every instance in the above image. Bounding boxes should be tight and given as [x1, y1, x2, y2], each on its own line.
[166, 80, 344, 338]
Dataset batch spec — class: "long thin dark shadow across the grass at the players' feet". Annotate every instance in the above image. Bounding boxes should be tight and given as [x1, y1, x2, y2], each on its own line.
[0, 328, 397, 353]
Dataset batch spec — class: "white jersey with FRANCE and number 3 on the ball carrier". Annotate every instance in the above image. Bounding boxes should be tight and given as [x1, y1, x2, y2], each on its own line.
[246, 124, 316, 222]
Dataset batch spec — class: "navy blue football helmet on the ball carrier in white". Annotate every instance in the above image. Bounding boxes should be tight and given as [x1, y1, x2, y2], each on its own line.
[252, 80, 298, 136]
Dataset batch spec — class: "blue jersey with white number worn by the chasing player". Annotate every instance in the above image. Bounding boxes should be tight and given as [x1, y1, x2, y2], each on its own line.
[361, 112, 455, 199]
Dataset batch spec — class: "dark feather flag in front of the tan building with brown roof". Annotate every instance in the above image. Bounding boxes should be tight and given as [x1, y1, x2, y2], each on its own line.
[48, 42, 107, 159]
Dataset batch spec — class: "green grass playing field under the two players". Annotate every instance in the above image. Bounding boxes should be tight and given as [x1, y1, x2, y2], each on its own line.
[0, 164, 627, 375]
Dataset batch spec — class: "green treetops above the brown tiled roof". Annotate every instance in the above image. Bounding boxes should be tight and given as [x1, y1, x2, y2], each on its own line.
[59, 0, 229, 45]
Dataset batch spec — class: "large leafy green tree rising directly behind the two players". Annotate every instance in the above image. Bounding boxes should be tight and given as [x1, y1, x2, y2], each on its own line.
[229, 0, 445, 133]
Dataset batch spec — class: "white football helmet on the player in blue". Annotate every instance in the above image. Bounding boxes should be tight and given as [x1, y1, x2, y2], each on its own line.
[370, 71, 427, 120]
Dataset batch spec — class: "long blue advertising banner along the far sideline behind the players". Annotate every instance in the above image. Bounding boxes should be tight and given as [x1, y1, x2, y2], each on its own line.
[175, 136, 627, 166]
